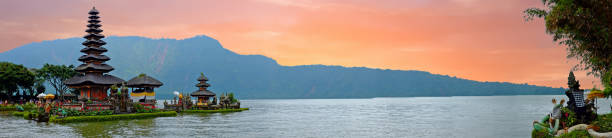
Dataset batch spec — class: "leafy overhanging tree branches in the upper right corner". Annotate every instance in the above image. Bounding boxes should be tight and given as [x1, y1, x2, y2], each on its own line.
[524, 0, 612, 92]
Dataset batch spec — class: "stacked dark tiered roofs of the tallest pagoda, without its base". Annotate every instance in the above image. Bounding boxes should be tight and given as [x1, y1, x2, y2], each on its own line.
[64, 7, 125, 86]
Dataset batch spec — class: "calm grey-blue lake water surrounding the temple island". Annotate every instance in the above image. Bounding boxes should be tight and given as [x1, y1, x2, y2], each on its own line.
[0, 95, 610, 137]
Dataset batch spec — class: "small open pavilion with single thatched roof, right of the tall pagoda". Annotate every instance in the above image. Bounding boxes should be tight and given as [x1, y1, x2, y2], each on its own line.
[126, 74, 164, 102]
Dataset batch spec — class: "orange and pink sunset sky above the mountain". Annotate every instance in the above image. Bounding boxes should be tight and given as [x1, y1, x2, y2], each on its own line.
[0, 0, 601, 88]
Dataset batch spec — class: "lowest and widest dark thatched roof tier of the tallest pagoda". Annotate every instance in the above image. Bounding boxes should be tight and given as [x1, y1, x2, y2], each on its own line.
[64, 74, 125, 86]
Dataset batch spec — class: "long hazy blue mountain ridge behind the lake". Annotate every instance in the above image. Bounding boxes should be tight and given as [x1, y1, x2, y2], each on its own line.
[0, 36, 564, 99]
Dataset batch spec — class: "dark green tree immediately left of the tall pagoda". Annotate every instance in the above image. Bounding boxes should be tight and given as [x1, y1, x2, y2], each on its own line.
[38, 64, 77, 99]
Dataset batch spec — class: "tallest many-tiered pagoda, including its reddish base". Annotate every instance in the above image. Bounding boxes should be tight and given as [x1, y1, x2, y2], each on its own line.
[64, 7, 125, 100]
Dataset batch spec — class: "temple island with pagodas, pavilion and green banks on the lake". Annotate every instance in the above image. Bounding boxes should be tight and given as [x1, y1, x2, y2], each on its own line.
[0, 7, 248, 123]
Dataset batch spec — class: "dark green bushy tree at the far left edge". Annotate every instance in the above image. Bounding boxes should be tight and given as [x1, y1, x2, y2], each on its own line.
[0, 62, 35, 98]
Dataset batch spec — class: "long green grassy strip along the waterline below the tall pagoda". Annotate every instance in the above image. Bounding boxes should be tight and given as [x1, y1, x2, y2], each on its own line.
[49, 111, 177, 123]
